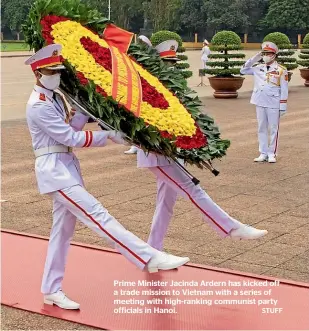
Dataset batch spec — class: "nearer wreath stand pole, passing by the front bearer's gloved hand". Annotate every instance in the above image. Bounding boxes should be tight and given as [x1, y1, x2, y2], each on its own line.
[59, 88, 200, 185]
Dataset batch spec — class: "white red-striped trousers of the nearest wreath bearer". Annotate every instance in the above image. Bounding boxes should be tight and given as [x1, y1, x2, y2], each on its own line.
[41, 185, 157, 294]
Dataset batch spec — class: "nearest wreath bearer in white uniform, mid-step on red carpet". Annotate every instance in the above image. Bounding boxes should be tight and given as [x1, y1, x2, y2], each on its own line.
[26, 44, 189, 309]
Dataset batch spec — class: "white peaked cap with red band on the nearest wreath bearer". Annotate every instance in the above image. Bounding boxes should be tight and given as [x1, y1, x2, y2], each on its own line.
[25, 44, 65, 71]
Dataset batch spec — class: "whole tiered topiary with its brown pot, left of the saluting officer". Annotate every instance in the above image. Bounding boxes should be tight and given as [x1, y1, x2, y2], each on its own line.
[203, 31, 245, 99]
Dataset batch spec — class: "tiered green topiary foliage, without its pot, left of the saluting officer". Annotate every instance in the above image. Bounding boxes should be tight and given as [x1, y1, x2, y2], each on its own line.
[203, 31, 245, 77]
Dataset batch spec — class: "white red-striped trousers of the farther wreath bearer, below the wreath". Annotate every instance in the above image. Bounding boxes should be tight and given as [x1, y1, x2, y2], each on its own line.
[148, 164, 239, 250]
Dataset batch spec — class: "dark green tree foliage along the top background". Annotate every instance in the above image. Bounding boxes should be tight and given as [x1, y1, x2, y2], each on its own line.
[1, 0, 309, 40]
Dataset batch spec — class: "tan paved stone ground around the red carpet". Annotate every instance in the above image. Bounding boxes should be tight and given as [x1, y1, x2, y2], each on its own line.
[1, 52, 309, 330]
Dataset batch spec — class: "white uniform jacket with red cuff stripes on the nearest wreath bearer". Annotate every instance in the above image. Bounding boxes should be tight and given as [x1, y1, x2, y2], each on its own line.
[27, 86, 108, 194]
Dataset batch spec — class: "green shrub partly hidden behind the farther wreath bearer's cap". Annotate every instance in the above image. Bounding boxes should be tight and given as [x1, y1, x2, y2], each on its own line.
[150, 30, 192, 78]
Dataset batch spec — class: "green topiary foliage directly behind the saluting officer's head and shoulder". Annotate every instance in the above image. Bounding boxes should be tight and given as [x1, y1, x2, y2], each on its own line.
[263, 32, 298, 81]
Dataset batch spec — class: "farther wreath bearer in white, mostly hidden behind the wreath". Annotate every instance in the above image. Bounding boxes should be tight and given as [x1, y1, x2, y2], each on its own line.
[137, 40, 267, 250]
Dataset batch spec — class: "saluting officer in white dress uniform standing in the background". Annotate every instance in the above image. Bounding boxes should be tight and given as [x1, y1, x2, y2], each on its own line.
[240, 42, 288, 163]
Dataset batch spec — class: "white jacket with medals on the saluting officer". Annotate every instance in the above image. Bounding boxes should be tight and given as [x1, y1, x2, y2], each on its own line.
[240, 56, 288, 112]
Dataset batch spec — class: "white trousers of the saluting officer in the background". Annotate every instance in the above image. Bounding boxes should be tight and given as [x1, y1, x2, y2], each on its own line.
[256, 106, 280, 157]
